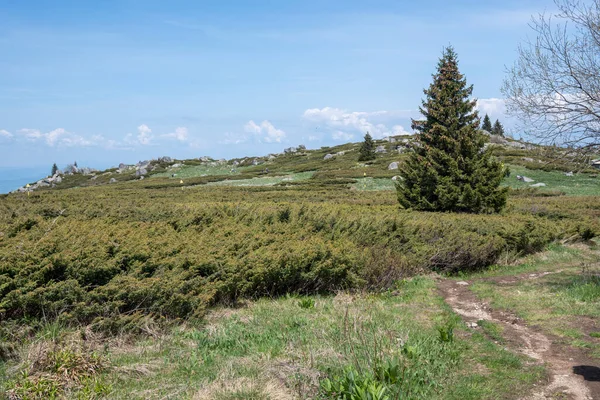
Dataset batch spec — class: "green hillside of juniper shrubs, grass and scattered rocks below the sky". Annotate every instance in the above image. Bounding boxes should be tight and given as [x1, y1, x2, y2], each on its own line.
[0, 137, 600, 400]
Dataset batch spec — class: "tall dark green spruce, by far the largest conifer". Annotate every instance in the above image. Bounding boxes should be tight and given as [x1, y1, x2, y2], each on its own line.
[396, 47, 508, 213]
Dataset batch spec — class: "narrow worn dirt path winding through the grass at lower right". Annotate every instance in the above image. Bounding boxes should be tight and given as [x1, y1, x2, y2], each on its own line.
[438, 274, 600, 400]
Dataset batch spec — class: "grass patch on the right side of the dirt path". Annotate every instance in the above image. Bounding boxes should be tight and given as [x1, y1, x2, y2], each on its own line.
[471, 246, 600, 357]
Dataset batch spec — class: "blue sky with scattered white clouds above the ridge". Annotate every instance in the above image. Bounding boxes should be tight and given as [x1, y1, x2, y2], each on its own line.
[0, 0, 554, 168]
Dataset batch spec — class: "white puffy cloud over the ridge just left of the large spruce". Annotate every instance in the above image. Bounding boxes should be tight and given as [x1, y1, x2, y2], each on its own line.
[303, 107, 412, 140]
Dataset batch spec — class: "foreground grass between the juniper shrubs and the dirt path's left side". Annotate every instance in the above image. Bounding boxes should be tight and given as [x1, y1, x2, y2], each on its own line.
[0, 277, 544, 400]
